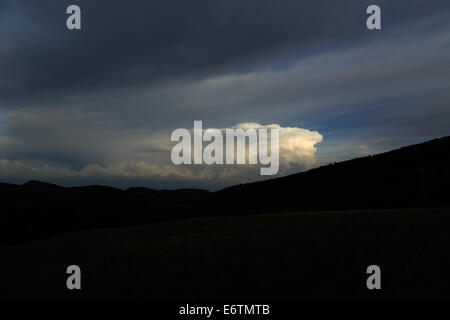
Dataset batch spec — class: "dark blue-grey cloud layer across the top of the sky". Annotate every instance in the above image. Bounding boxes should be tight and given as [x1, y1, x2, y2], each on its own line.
[0, 0, 450, 99]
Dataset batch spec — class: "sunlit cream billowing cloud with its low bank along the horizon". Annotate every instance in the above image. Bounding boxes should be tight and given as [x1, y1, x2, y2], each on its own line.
[0, 122, 323, 185]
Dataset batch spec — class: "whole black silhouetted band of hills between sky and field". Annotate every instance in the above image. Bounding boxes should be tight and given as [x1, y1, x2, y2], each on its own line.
[0, 137, 450, 244]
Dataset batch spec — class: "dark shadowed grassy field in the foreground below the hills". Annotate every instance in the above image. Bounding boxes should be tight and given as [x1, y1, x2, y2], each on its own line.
[0, 208, 450, 299]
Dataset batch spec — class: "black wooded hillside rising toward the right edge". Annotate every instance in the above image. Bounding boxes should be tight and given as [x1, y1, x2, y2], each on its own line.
[206, 137, 450, 214]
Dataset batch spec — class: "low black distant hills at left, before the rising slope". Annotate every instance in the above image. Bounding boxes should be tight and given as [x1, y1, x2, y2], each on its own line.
[0, 181, 209, 244]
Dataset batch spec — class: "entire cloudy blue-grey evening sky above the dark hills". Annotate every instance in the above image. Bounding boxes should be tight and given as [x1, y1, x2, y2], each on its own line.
[0, 0, 450, 190]
